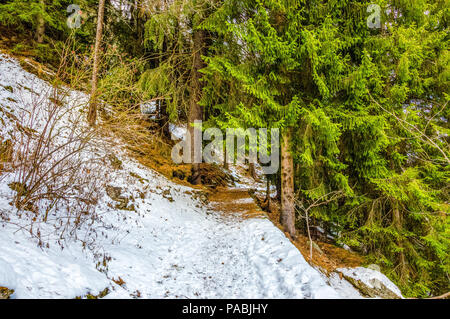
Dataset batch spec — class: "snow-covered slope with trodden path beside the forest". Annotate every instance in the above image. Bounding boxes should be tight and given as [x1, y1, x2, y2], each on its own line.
[0, 54, 358, 298]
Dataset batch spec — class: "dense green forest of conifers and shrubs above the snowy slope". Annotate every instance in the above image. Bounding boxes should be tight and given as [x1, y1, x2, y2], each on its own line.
[0, 0, 450, 297]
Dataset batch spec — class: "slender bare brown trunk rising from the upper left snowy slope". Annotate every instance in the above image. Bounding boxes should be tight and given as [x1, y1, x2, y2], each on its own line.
[88, 0, 105, 126]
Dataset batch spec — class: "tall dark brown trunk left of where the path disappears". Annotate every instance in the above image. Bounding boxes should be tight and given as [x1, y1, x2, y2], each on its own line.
[188, 30, 205, 185]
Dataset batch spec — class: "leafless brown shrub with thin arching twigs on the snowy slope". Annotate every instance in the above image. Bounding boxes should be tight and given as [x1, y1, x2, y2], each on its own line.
[1, 67, 102, 245]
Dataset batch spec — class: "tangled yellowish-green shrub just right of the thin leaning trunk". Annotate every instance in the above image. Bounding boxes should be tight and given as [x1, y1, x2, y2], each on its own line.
[94, 46, 171, 165]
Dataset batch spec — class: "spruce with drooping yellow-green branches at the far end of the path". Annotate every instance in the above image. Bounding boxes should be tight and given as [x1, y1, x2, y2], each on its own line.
[141, 0, 214, 184]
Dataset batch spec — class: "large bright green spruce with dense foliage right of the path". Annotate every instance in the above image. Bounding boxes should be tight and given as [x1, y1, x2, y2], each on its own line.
[203, 0, 450, 296]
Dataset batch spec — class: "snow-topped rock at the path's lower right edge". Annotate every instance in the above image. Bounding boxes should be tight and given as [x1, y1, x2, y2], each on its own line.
[336, 267, 403, 299]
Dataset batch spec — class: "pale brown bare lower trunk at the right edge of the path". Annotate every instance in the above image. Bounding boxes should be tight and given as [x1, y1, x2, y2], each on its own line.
[280, 129, 295, 238]
